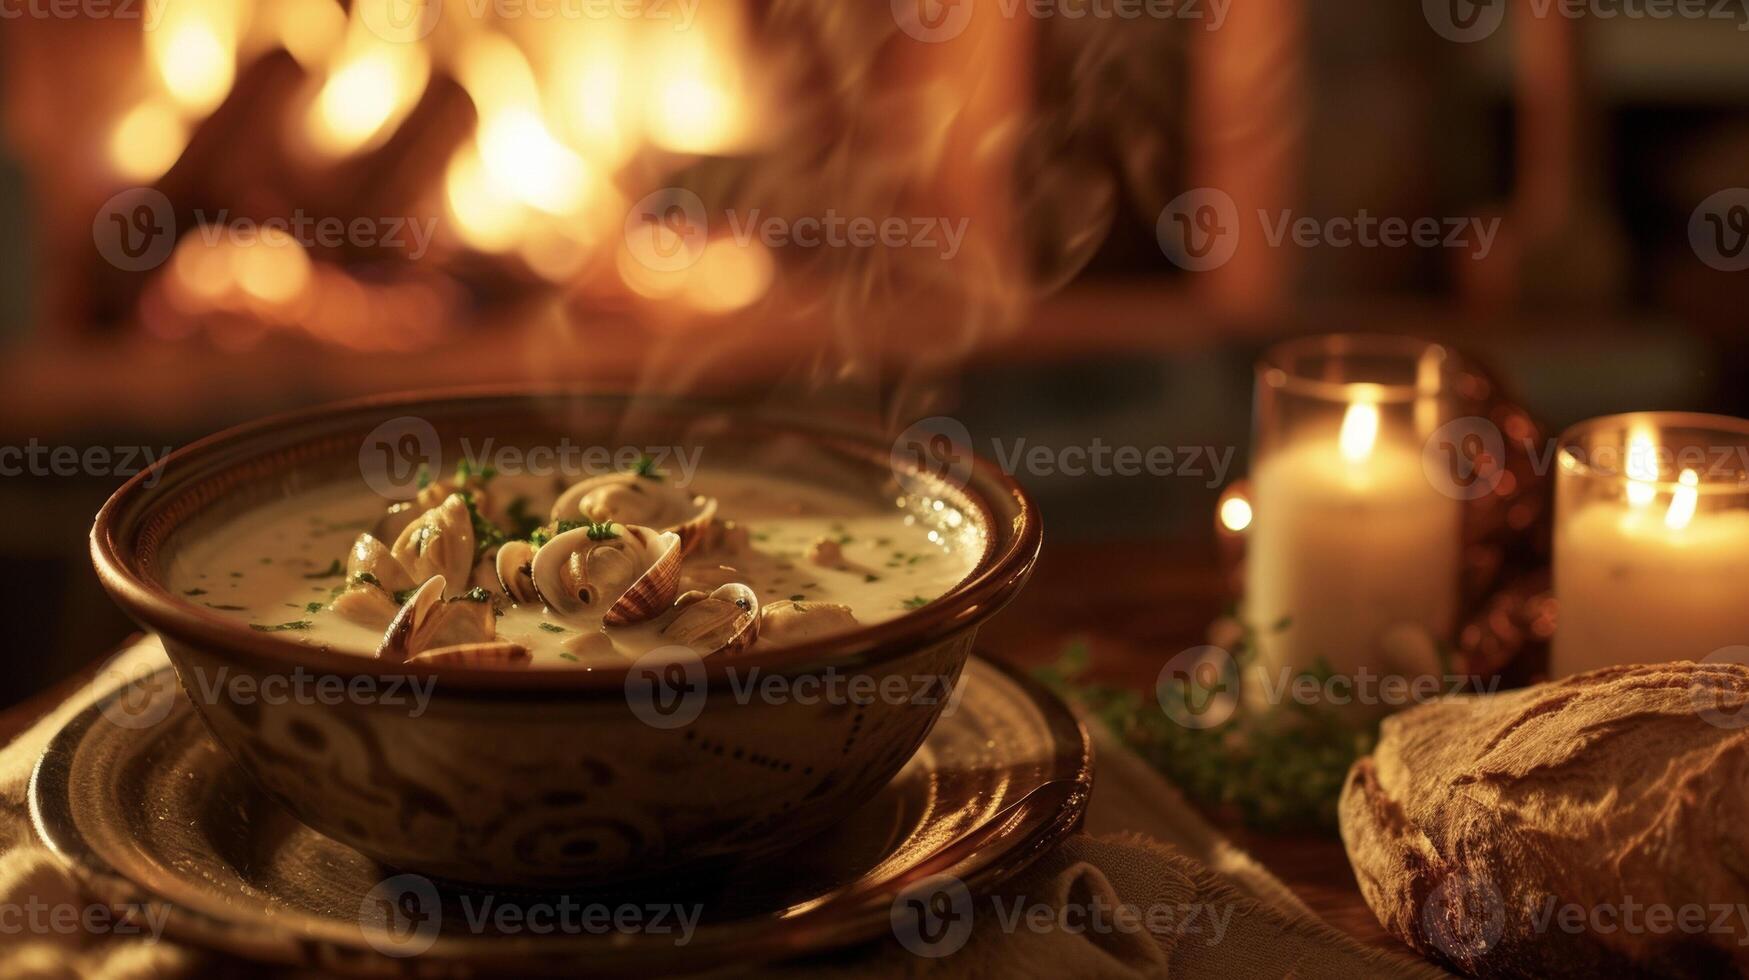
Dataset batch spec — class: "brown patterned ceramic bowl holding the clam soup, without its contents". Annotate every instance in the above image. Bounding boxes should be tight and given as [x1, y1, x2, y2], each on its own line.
[91, 392, 1041, 886]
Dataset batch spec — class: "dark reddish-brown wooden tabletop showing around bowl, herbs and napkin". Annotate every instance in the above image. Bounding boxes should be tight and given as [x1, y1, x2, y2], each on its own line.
[0, 543, 1406, 950]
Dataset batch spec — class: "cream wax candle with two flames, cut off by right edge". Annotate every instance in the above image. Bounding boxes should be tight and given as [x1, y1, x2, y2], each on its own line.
[1550, 467, 1749, 677]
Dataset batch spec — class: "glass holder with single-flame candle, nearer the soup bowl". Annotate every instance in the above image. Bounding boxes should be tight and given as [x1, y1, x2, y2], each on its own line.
[1244, 334, 1476, 690]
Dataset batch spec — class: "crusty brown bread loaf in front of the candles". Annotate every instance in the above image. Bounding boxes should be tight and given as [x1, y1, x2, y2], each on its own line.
[1341, 663, 1749, 977]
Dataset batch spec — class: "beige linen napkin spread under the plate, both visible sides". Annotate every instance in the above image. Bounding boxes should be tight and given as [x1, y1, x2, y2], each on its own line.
[0, 637, 1448, 980]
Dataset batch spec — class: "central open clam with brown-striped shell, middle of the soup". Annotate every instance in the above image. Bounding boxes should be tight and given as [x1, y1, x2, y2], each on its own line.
[530, 525, 680, 627]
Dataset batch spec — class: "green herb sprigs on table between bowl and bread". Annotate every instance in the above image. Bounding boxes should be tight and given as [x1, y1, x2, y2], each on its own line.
[1035, 632, 1378, 831]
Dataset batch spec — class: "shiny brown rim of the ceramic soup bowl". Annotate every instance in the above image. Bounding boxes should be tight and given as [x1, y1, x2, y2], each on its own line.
[91, 383, 1042, 698]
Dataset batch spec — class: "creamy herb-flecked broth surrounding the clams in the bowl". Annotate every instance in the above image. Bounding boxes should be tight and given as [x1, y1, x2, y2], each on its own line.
[168, 469, 985, 667]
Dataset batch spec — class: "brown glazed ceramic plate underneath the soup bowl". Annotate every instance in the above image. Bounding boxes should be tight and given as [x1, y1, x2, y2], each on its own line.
[30, 658, 1093, 975]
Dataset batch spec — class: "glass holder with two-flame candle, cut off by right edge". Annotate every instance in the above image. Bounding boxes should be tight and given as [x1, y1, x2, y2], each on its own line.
[1550, 411, 1749, 677]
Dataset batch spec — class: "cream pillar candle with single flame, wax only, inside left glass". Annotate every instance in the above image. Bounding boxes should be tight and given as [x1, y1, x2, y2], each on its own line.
[1244, 401, 1462, 695]
